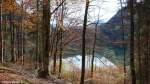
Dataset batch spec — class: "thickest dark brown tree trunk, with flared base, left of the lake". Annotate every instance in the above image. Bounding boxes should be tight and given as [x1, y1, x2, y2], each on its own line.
[39, 0, 50, 78]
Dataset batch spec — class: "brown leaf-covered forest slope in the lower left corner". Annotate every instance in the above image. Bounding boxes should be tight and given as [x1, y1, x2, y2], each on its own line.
[0, 64, 66, 84]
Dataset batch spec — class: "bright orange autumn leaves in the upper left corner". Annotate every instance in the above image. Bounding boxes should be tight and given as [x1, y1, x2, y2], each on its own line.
[2, 0, 37, 29]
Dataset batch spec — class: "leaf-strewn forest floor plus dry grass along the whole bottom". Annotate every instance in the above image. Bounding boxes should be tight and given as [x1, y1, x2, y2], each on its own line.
[0, 63, 126, 84]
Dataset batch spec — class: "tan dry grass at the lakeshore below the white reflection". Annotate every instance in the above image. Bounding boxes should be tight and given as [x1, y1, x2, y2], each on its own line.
[55, 66, 127, 84]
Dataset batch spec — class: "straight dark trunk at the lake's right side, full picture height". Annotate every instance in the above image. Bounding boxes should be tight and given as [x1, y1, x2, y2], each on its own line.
[130, 0, 136, 84]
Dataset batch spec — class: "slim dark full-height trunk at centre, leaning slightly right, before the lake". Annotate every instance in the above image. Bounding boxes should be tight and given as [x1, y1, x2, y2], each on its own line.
[80, 0, 89, 84]
